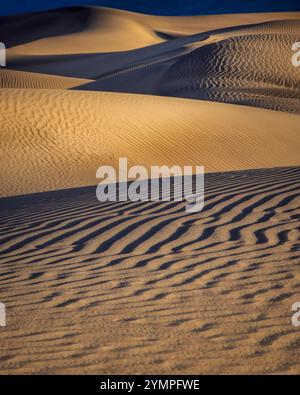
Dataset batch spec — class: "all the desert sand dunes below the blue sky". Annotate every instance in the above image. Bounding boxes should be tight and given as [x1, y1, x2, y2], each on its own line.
[0, 8, 300, 374]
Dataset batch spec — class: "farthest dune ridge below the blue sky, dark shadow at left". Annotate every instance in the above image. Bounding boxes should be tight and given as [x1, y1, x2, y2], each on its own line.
[0, 7, 300, 55]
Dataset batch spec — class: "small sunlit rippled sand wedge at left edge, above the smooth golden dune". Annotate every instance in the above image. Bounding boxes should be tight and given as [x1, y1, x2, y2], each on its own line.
[0, 68, 91, 89]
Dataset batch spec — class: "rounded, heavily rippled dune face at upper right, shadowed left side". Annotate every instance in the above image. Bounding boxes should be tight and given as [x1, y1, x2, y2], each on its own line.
[160, 20, 300, 113]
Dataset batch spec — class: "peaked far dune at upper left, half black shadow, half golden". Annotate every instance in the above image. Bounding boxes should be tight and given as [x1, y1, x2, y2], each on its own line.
[0, 7, 163, 56]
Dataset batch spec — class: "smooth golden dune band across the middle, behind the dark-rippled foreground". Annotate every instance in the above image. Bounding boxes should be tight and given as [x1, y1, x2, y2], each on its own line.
[0, 89, 300, 196]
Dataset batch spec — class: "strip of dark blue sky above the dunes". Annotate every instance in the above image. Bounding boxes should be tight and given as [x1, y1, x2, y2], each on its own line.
[0, 0, 300, 15]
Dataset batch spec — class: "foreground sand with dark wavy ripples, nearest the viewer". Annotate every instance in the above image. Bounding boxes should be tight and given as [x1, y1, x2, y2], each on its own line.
[0, 167, 300, 374]
